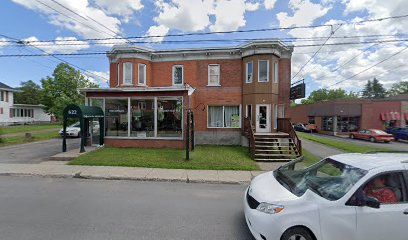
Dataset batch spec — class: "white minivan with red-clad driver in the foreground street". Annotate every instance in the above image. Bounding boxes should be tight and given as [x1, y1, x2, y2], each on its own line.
[244, 153, 408, 240]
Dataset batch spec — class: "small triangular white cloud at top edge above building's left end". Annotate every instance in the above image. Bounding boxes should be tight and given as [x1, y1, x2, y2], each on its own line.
[95, 0, 144, 22]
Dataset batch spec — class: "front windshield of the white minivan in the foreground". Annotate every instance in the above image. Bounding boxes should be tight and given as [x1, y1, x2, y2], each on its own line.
[274, 158, 367, 201]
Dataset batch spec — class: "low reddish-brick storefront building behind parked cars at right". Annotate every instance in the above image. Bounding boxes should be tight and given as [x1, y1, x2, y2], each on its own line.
[287, 94, 408, 135]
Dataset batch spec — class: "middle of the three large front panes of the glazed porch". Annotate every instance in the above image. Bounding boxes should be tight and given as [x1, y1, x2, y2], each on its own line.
[130, 99, 154, 138]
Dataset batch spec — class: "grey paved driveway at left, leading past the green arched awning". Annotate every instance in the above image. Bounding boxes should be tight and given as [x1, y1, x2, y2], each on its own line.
[0, 138, 80, 163]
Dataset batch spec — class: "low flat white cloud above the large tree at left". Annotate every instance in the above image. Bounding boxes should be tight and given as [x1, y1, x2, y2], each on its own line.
[23, 36, 89, 54]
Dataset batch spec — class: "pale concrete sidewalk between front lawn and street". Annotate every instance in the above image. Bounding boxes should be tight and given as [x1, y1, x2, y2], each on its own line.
[0, 161, 262, 184]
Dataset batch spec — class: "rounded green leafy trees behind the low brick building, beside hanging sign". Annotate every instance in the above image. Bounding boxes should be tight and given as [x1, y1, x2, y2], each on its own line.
[301, 88, 358, 104]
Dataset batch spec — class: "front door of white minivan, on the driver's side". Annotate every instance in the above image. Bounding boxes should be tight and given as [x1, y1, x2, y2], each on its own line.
[356, 171, 408, 240]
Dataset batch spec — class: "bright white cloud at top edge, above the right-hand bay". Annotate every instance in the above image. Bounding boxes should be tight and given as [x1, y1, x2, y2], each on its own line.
[276, 0, 329, 27]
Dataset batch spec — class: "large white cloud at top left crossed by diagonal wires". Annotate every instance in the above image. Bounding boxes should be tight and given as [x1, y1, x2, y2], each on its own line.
[12, 0, 135, 38]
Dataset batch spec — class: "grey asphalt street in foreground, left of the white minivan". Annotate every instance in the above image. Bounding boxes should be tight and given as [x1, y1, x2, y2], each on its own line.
[0, 176, 253, 240]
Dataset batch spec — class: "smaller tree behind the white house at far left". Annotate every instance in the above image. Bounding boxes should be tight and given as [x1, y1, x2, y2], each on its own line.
[14, 80, 42, 104]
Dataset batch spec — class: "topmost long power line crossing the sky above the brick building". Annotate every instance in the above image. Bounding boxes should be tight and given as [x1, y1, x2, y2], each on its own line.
[3, 13, 408, 42]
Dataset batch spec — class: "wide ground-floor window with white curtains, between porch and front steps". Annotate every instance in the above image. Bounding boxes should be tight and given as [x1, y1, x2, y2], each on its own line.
[208, 106, 241, 128]
